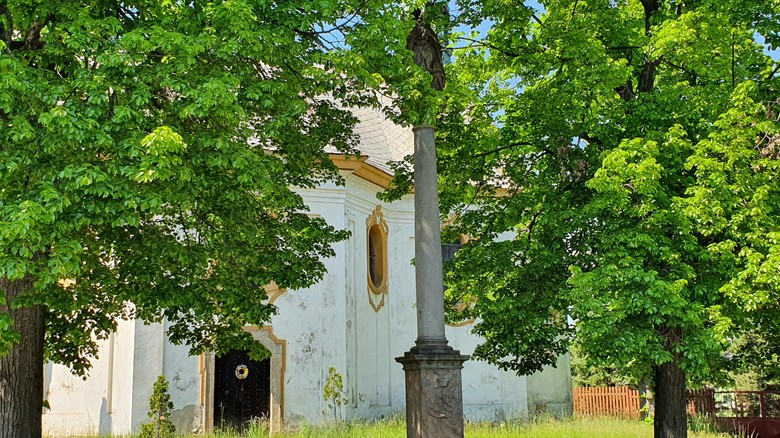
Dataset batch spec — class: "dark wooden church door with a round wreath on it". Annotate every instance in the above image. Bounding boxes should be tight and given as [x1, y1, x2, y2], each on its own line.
[214, 350, 271, 430]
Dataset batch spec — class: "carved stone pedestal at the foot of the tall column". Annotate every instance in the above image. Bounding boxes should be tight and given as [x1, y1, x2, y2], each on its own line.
[395, 338, 469, 438]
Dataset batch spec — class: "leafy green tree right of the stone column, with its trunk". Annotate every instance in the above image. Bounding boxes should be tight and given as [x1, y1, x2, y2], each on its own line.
[390, 0, 780, 437]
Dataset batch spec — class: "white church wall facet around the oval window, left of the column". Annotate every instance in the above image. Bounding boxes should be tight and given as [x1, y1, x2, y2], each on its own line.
[346, 179, 415, 418]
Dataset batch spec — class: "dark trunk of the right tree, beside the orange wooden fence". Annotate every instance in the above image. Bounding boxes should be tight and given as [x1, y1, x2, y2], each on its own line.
[654, 359, 688, 438]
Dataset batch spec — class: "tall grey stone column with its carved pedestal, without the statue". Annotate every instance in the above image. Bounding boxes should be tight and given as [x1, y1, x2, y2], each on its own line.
[395, 125, 469, 438]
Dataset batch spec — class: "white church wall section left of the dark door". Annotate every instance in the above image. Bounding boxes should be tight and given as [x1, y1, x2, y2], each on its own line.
[43, 308, 207, 436]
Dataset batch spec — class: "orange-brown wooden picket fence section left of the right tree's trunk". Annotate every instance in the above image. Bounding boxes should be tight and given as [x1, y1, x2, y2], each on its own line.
[574, 386, 640, 419]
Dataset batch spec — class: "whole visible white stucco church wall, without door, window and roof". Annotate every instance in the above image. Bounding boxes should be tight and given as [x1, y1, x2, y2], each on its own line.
[39, 172, 571, 436]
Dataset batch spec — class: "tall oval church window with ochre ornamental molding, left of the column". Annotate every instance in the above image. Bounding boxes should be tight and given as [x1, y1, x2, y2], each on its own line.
[366, 205, 390, 312]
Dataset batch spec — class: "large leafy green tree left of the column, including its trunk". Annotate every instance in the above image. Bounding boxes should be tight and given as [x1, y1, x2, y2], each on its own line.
[0, 0, 390, 438]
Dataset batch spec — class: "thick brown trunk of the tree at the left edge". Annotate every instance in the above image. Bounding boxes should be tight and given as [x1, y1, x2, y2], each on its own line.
[0, 277, 45, 438]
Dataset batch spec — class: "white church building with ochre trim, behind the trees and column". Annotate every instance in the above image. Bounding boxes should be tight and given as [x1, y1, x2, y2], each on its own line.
[43, 110, 572, 436]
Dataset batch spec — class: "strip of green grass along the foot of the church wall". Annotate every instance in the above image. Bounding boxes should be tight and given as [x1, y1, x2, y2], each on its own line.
[200, 418, 727, 438]
